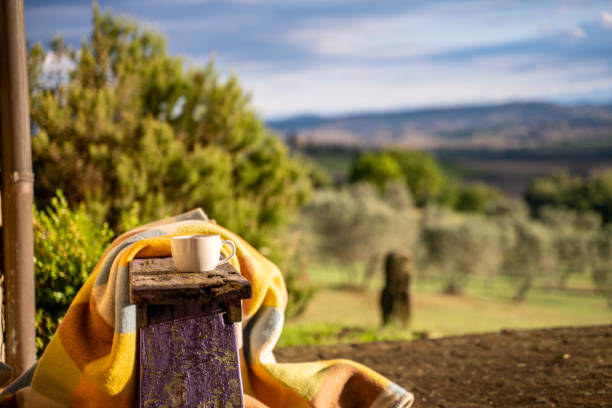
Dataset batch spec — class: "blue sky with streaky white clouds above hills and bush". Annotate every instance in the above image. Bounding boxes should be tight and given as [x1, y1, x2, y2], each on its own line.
[24, 0, 612, 119]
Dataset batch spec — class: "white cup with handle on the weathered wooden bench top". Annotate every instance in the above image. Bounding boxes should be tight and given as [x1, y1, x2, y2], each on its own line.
[170, 234, 236, 272]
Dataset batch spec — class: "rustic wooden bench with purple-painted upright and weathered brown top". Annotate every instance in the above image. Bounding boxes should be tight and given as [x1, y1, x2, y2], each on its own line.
[129, 258, 251, 408]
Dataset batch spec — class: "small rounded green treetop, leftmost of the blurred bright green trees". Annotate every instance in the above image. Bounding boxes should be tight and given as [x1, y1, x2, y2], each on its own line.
[349, 153, 402, 192]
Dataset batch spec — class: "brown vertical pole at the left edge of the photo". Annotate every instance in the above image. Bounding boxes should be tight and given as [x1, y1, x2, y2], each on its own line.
[0, 0, 36, 375]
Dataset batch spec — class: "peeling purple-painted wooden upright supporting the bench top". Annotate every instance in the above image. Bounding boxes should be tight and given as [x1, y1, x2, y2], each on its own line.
[140, 306, 243, 408]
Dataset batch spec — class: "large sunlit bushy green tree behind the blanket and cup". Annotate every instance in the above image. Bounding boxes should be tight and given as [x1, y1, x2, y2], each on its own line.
[29, 5, 310, 247]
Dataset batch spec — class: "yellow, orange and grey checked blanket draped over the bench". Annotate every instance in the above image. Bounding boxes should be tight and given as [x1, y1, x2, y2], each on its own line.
[10, 210, 413, 408]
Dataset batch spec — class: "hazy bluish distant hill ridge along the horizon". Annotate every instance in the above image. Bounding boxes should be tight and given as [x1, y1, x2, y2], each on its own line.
[268, 102, 612, 150]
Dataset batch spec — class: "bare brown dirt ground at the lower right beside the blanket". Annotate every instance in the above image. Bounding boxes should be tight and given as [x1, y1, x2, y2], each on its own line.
[275, 325, 612, 408]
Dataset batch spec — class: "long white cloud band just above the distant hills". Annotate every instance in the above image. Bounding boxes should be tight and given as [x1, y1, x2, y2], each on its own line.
[237, 57, 612, 117]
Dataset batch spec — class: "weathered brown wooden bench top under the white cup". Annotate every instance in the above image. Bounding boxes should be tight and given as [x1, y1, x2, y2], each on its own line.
[129, 258, 252, 305]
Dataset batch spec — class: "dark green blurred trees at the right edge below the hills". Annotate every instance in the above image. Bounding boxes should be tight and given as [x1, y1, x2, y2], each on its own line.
[525, 170, 612, 223]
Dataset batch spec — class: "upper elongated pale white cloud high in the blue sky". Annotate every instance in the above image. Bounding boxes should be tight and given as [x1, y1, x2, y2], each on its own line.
[283, 8, 538, 59]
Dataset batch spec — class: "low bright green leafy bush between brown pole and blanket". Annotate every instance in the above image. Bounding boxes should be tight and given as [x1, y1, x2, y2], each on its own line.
[34, 190, 113, 352]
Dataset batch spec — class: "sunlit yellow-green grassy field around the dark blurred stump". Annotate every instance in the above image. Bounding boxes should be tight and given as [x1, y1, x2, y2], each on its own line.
[279, 266, 612, 346]
